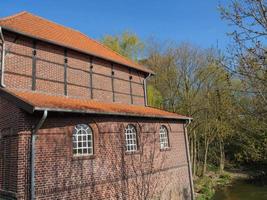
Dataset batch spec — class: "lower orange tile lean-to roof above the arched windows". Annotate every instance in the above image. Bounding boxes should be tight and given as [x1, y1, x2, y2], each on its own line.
[0, 89, 191, 119]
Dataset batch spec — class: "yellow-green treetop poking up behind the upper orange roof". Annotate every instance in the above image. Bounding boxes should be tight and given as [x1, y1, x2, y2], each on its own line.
[101, 32, 144, 60]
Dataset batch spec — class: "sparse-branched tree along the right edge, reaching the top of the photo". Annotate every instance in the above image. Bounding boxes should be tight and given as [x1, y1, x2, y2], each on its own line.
[220, 0, 267, 166]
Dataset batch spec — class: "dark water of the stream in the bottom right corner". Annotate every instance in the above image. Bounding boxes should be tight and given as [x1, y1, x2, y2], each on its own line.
[213, 180, 267, 200]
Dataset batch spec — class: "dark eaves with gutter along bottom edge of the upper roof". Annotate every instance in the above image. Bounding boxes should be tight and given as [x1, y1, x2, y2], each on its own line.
[0, 25, 155, 75]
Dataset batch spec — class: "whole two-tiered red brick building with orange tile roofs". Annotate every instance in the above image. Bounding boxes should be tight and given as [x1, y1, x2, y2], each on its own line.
[0, 12, 193, 200]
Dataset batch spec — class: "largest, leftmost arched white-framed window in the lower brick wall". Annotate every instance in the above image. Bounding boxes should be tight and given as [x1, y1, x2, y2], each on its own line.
[72, 124, 94, 156]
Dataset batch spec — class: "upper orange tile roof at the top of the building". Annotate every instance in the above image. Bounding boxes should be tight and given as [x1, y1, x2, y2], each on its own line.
[0, 12, 154, 74]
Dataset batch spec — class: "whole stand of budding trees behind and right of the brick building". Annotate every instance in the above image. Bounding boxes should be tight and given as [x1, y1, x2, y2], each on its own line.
[101, 24, 267, 188]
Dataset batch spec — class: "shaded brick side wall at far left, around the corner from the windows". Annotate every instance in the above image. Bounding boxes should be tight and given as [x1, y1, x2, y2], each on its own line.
[0, 97, 30, 199]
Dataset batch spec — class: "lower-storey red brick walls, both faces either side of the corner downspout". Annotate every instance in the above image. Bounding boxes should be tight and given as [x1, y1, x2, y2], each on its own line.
[0, 102, 193, 200]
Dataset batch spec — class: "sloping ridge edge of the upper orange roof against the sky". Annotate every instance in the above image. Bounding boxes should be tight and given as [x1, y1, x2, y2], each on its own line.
[23, 11, 142, 68]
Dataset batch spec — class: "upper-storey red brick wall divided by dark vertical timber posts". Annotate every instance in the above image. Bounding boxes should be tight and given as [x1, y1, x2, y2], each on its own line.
[2, 32, 145, 105]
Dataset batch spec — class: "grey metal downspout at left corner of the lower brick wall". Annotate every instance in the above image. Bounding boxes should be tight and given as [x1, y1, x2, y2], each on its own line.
[31, 110, 48, 200]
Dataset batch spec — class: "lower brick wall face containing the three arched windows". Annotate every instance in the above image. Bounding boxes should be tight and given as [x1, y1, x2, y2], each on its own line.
[29, 115, 190, 199]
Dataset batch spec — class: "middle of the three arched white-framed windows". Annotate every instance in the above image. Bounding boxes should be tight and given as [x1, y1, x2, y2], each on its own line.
[125, 124, 138, 152]
